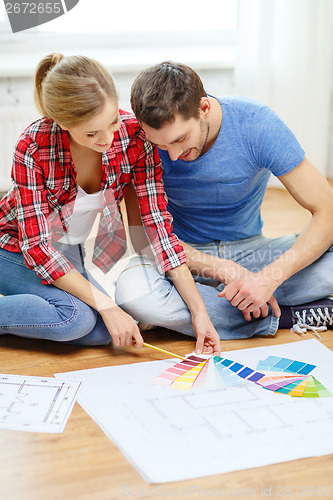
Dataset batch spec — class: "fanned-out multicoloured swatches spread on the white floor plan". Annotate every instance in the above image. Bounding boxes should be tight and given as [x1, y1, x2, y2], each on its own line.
[153, 356, 332, 398]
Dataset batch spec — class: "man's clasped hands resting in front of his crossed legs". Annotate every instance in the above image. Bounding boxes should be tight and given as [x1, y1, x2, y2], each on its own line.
[218, 271, 281, 321]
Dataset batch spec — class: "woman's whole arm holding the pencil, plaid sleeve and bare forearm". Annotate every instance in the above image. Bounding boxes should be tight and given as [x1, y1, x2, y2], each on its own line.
[12, 129, 142, 347]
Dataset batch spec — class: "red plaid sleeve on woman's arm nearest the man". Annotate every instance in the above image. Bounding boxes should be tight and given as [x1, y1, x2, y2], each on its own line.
[133, 129, 186, 273]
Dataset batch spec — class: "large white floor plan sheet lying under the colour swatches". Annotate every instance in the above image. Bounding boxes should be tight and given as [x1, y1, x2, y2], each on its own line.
[55, 339, 333, 483]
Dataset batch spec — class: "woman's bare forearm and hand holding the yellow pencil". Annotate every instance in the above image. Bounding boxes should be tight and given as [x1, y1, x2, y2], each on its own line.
[53, 269, 143, 347]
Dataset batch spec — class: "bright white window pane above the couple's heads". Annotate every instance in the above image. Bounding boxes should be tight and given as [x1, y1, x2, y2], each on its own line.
[40, 0, 237, 33]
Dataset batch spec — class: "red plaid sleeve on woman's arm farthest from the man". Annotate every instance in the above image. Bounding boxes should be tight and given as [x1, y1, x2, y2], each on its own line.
[12, 137, 74, 284]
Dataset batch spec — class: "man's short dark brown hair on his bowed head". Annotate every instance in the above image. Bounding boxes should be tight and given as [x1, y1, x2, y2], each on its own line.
[131, 61, 207, 129]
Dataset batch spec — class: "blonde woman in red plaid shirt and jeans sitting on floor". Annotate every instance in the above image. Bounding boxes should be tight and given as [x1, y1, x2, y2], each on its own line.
[0, 54, 219, 353]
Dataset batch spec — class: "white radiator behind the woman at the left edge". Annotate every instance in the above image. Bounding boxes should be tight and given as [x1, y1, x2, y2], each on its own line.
[0, 106, 38, 191]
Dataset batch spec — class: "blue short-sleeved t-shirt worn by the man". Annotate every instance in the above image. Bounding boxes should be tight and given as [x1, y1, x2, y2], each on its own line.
[159, 97, 305, 243]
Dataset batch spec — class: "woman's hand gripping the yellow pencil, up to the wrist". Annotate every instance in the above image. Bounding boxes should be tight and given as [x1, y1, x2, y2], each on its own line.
[100, 306, 143, 348]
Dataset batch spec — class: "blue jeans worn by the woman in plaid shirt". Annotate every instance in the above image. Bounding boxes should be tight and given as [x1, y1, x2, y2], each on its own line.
[0, 245, 111, 345]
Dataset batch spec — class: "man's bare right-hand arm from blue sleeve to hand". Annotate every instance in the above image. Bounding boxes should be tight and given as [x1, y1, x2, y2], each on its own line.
[219, 158, 333, 312]
